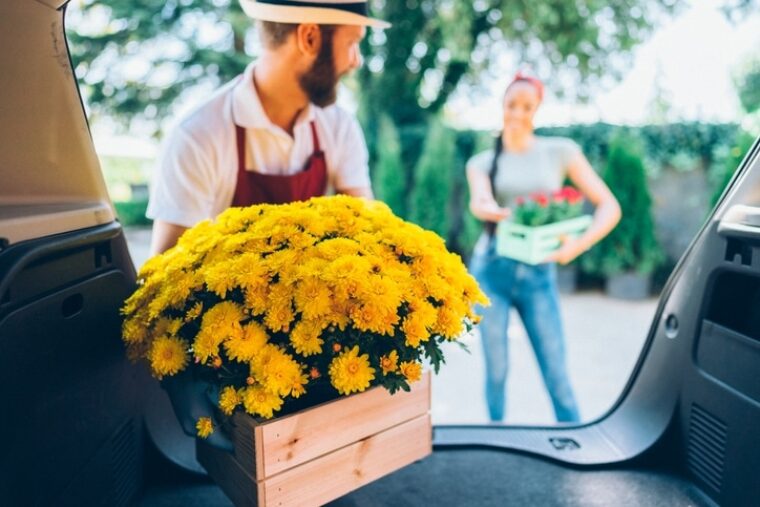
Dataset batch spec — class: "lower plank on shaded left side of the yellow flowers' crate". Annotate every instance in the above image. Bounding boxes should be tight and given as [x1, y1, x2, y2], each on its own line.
[195, 439, 266, 507]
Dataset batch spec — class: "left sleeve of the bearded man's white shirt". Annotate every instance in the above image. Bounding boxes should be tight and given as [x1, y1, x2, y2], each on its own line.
[146, 127, 214, 227]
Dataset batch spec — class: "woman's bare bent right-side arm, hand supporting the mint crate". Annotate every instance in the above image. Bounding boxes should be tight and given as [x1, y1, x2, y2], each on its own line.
[547, 153, 622, 264]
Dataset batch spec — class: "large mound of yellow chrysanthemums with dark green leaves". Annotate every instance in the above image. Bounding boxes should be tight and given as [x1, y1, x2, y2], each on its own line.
[122, 196, 488, 436]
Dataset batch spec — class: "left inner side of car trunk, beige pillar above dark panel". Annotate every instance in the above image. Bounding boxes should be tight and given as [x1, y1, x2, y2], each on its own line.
[0, 0, 146, 506]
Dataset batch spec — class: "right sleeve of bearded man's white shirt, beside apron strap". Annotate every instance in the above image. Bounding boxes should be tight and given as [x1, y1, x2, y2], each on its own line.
[334, 115, 372, 190]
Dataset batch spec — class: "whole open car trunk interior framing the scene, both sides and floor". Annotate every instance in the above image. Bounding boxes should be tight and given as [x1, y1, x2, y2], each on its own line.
[0, 0, 760, 506]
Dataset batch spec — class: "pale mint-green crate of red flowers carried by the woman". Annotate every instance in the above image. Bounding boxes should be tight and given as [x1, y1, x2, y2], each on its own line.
[496, 215, 593, 264]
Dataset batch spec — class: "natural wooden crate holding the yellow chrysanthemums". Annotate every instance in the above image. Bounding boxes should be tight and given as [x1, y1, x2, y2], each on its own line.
[197, 373, 432, 507]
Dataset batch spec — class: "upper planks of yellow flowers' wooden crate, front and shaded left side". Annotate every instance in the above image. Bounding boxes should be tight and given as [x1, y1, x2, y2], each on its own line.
[235, 372, 430, 480]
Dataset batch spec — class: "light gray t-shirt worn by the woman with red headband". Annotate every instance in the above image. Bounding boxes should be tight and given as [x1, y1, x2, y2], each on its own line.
[467, 136, 581, 207]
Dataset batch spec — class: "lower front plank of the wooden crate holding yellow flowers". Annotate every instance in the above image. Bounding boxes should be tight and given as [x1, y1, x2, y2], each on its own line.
[262, 414, 432, 507]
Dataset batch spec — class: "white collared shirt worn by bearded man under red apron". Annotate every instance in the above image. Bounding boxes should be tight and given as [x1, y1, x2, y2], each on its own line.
[147, 63, 370, 227]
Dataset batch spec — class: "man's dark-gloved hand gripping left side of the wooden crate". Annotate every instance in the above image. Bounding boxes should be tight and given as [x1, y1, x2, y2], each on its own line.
[161, 370, 233, 452]
